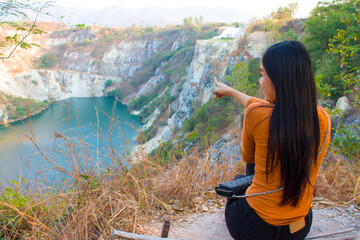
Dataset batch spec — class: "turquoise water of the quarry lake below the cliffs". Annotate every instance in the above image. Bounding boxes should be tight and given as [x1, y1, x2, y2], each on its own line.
[0, 98, 140, 183]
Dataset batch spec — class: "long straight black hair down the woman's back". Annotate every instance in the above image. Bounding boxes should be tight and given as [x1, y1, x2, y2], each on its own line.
[262, 41, 320, 206]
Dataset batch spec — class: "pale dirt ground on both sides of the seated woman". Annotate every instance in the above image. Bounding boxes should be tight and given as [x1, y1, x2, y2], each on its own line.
[141, 204, 360, 240]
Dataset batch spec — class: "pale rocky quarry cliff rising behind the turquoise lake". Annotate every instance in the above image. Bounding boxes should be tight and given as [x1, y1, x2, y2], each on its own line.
[0, 23, 271, 150]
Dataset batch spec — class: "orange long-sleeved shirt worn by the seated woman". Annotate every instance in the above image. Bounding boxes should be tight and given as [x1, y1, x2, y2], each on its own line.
[241, 97, 330, 226]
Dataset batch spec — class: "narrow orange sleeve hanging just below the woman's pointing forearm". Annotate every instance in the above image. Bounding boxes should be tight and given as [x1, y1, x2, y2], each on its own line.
[241, 101, 257, 163]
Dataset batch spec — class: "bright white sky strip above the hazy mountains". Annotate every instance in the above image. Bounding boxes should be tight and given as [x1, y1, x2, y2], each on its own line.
[56, 0, 318, 18]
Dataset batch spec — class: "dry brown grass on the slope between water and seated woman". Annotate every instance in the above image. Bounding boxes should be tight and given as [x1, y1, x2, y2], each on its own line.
[0, 123, 243, 239]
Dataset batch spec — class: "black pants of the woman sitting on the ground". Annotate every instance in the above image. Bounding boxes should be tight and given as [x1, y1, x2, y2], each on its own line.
[225, 164, 312, 240]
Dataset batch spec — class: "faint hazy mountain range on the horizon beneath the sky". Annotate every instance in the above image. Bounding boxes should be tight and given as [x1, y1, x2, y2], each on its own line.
[40, 5, 254, 27]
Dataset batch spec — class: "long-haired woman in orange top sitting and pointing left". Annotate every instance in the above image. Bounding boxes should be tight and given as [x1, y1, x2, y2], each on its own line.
[214, 41, 330, 239]
